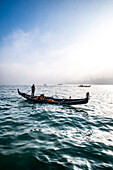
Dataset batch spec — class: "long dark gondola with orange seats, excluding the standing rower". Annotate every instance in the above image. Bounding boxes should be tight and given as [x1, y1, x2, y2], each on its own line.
[17, 89, 89, 105]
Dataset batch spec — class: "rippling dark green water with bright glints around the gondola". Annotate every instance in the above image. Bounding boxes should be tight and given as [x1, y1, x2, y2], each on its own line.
[0, 85, 113, 170]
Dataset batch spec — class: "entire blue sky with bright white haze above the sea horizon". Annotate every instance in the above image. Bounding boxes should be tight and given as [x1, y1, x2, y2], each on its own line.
[0, 0, 113, 85]
